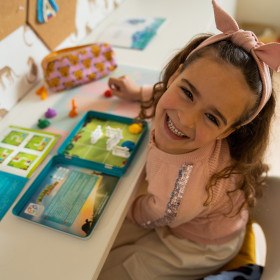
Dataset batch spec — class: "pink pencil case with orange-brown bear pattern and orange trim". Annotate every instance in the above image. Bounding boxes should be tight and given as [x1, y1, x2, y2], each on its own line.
[42, 43, 117, 91]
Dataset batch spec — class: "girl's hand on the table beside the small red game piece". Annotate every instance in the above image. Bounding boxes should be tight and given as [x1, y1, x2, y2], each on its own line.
[108, 75, 141, 101]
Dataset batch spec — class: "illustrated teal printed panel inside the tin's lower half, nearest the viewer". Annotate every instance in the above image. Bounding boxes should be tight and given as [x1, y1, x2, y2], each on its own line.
[18, 162, 119, 237]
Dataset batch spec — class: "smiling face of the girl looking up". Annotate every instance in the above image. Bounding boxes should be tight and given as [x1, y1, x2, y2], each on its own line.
[154, 57, 255, 154]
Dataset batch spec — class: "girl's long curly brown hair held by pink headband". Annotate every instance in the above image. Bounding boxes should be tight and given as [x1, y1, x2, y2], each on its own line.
[138, 34, 275, 212]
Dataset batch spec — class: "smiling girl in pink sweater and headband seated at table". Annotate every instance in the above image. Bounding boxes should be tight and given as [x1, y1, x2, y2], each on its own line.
[99, 1, 280, 280]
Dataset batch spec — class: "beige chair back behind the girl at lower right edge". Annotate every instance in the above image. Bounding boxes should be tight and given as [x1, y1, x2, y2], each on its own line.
[252, 177, 280, 280]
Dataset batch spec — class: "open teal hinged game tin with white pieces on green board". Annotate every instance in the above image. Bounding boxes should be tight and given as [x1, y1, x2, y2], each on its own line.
[13, 111, 148, 238]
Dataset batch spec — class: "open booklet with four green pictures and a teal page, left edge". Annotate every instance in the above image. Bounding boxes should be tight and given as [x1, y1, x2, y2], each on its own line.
[0, 125, 60, 220]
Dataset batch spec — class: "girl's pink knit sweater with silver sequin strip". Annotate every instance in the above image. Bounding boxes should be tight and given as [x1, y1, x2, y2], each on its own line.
[128, 86, 248, 244]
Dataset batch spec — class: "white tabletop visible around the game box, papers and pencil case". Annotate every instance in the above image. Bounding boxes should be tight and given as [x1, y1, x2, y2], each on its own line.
[0, 0, 279, 280]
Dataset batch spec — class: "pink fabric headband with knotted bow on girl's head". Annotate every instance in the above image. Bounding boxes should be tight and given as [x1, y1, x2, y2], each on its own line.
[188, 0, 280, 125]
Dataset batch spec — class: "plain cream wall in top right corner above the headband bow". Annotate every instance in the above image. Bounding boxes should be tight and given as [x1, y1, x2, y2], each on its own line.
[236, 0, 280, 31]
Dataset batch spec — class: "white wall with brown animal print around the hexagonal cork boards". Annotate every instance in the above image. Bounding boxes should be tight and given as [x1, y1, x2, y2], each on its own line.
[0, 0, 124, 116]
